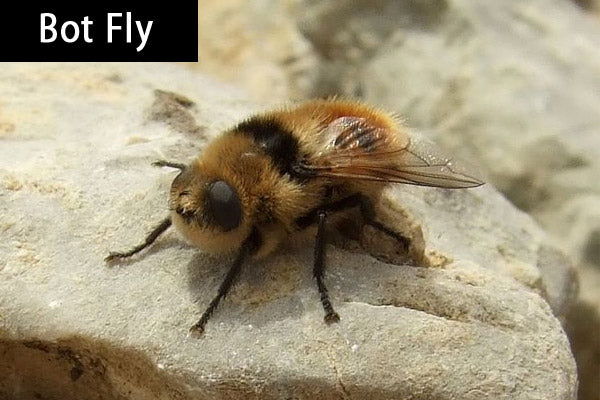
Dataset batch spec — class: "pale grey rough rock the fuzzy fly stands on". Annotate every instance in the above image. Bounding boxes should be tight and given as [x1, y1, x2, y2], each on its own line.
[0, 64, 577, 400]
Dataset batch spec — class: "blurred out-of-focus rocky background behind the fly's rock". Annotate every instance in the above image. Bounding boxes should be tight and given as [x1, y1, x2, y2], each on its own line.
[189, 0, 600, 400]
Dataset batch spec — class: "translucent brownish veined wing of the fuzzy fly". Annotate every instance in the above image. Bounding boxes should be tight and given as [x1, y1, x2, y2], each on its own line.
[301, 117, 483, 189]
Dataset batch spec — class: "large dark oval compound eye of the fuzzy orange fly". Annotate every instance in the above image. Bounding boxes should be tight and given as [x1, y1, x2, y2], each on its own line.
[207, 181, 242, 232]
